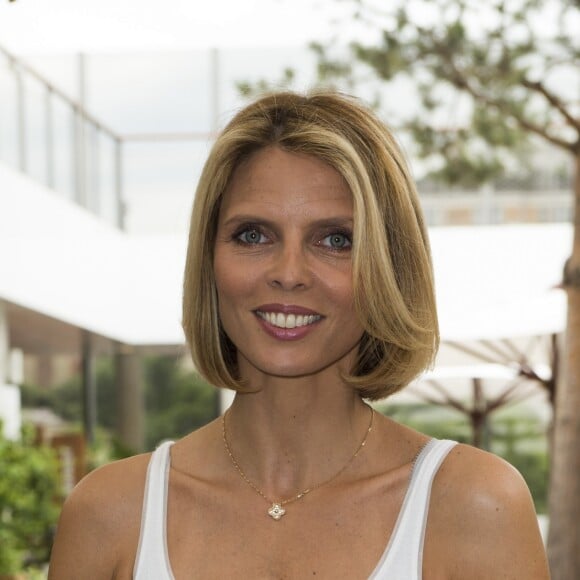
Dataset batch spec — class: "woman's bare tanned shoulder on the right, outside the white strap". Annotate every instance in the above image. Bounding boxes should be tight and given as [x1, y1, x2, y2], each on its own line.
[426, 445, 549, 580]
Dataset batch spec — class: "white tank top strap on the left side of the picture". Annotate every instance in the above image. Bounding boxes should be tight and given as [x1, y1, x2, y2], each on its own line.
[133, 441, 174, 580]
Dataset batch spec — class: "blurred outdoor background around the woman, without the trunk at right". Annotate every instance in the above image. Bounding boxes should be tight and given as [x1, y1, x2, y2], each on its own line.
[0, 0, 580, 580]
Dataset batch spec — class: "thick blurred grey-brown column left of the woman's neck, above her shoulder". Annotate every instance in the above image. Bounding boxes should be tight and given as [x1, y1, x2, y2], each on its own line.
[115, 344, 145, 453]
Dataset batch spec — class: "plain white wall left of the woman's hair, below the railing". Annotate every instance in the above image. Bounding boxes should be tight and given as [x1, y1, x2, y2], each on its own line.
[0, 163, 186, 344]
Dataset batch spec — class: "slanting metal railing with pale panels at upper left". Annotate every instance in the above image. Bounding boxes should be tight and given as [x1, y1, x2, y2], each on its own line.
[0, 47, 124, 228]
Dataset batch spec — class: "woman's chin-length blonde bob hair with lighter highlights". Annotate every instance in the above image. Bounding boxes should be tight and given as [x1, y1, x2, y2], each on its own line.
[183, 92, 439, 400]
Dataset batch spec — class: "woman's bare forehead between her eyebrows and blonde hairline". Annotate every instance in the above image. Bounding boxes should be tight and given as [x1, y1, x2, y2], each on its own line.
[220, 146, 352, 213]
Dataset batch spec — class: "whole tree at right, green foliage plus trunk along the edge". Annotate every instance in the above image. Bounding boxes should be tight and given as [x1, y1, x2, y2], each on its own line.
[251, 0, 580, 580]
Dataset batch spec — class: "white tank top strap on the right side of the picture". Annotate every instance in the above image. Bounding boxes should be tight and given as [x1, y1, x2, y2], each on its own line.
[370, 439, 457, 580]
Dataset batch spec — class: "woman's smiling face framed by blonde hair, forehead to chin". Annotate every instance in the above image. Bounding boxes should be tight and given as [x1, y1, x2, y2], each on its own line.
[214, 147, 363, 378]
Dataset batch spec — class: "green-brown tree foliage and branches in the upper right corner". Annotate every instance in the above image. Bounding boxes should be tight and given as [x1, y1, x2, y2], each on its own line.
[312, 0, 580, 186]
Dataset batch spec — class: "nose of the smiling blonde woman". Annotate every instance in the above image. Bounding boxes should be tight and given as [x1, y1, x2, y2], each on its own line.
[268, 242, 312, 290]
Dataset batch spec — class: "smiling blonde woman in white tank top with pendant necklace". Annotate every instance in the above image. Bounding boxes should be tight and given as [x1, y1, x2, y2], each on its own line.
[50, 93, 549, 580]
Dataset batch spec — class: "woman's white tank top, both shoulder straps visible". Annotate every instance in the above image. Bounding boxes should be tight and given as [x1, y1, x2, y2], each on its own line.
[133, 439, 456, 580]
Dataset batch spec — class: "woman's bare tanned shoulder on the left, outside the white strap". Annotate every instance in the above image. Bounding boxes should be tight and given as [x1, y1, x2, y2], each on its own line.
[49, 454, 150, 580]
